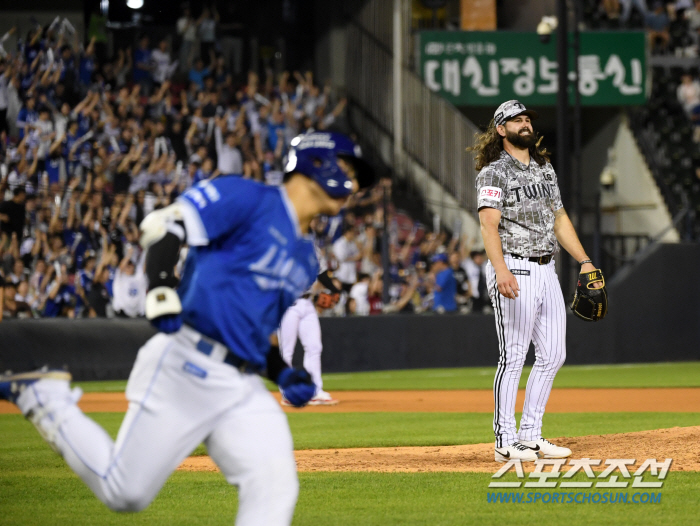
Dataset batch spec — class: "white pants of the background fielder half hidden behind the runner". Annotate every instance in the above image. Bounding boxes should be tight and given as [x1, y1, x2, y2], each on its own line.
[279, 298, 323, 391]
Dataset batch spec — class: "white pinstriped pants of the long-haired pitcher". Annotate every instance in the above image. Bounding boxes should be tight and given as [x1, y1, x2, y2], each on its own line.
[486, 255, 566, 447]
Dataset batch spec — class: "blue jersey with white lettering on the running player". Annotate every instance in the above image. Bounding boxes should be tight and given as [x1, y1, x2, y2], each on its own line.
[178, 177, 319, 368]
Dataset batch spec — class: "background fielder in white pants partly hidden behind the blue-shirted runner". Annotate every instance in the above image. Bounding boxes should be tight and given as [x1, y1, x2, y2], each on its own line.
[279, 260, 344, 406]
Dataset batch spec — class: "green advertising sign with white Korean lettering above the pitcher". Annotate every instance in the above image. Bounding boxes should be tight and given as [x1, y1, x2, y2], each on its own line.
[419, 31, 647, 106]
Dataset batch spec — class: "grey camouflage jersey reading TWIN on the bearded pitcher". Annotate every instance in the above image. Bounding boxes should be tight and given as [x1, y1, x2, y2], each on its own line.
[476, 151, 564, 257]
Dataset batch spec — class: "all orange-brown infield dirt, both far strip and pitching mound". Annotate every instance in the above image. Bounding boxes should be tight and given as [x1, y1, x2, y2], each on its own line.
[0, 388, 700, 473]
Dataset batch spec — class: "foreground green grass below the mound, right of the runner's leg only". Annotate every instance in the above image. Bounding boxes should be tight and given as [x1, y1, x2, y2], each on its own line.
[294, 473, 700, 526]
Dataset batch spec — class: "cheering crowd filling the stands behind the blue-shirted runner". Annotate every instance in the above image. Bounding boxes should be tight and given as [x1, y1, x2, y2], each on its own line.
[0, 15, 488, 319]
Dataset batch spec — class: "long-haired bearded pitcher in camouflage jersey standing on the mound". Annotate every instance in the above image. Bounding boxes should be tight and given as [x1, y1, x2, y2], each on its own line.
[470, 100, 602, 462]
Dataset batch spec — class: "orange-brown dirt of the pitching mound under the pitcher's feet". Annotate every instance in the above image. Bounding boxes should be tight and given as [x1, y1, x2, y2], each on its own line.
[178, 426, 700, 473]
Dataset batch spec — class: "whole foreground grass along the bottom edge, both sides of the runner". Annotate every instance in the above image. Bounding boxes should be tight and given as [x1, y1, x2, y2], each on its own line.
[0, 466, 700, 526]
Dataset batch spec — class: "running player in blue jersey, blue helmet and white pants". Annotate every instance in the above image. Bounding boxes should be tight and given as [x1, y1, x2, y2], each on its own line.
[0, 133, 373, 525]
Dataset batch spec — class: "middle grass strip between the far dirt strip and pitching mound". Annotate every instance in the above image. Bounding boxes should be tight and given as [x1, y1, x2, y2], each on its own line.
[0, 413, 700, 454]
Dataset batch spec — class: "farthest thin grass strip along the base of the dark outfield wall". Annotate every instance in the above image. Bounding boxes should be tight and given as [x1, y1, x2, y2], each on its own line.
[76, 364, 700, 392]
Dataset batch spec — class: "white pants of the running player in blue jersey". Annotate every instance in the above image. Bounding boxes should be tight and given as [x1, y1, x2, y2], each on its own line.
[18, 327, 299, 526]
